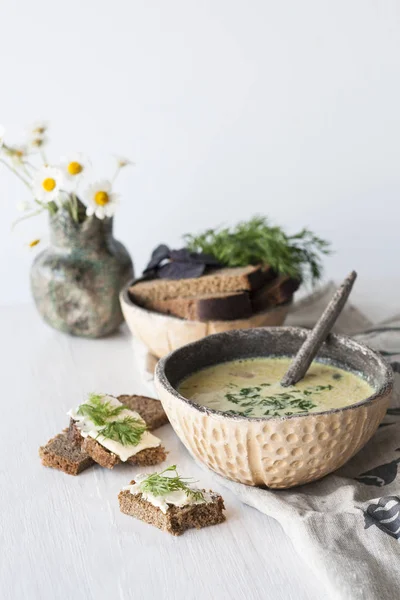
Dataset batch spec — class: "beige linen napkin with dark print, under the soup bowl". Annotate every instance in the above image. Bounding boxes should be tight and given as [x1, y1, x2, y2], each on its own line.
[138, 284, 400, 600]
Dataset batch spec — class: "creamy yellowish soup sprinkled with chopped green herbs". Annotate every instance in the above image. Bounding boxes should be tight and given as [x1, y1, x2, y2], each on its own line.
[178, 358, 374, 417]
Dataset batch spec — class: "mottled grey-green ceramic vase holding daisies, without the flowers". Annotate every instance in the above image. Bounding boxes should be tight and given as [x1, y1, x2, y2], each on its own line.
[31, 209, 134, 338]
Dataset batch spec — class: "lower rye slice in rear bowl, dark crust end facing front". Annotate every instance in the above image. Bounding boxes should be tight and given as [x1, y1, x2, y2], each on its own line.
[152, 292, 253, 321]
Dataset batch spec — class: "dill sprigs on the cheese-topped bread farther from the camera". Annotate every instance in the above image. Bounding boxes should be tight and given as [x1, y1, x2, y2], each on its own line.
[77, 394, 147, 446]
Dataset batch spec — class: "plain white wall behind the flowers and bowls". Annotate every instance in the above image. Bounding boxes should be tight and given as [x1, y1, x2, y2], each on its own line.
[0, 0, 400, 312]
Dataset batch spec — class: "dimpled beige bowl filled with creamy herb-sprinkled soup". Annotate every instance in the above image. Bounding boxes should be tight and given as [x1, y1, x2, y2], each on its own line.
[155, 327, 393, 488]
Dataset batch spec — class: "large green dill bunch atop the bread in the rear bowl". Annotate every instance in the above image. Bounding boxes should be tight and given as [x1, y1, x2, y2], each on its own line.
[184, 216, 331, 284]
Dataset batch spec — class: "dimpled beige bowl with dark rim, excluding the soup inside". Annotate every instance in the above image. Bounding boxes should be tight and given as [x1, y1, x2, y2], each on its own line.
[155, 327, 393, 488]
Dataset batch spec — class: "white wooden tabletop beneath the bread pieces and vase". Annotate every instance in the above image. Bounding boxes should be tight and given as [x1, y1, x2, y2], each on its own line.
[0, 306, 334, 600]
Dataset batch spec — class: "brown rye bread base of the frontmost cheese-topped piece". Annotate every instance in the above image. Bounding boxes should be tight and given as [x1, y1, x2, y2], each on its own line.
[118, 481, 225, 535]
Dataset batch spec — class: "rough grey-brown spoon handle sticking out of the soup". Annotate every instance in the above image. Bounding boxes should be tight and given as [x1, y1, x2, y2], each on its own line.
[281, 271, 357, 387]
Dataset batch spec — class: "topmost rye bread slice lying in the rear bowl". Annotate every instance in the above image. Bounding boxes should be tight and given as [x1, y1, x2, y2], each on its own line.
[129, 265, 268, 309]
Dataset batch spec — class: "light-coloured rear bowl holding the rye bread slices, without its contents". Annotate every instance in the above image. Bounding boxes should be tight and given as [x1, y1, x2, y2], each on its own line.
[120, 282, 290, 358]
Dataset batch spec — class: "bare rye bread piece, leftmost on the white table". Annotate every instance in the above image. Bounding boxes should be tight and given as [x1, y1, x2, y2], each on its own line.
[39, 429, 94, 475]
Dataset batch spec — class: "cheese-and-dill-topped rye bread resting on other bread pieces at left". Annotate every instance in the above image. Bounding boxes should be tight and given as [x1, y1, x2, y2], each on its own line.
[69, 395, 166, 469]
